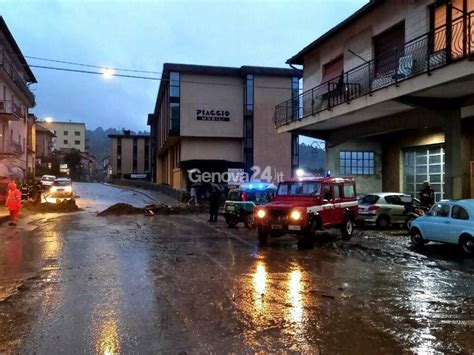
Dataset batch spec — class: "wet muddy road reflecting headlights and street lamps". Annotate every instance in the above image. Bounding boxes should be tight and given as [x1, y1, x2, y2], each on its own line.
[0, 186, 474, 354]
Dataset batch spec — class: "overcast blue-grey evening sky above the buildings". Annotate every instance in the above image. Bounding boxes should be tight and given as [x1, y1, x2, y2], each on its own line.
[0, 0, 367, 135]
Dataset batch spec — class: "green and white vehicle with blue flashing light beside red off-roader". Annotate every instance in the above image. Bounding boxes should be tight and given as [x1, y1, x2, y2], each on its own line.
[224, 182, 276, 228]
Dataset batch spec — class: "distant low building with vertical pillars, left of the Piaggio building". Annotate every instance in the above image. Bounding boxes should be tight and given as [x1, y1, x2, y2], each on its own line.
[109, 131, 151, 180]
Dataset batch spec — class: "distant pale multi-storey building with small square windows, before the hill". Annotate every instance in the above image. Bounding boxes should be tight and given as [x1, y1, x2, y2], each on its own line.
[41, 121, 86, 152]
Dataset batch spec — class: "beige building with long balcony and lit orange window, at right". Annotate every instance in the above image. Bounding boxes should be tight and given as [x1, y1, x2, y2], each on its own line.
[275, 0, 474, 200]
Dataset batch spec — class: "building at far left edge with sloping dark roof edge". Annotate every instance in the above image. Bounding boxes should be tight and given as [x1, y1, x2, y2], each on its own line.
[0, 16, 36, 180]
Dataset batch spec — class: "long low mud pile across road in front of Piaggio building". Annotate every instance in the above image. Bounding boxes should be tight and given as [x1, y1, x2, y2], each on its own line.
[97, 203, 208, 217]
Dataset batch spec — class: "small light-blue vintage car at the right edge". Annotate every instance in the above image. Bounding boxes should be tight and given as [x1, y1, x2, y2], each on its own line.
[410, 200, 474, 255]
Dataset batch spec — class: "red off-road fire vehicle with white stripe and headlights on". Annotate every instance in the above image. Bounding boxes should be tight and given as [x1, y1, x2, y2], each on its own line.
[255, 177, 357, 246]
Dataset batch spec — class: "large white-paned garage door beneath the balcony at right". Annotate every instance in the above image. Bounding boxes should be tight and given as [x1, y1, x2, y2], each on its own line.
[403, 145, 444, 201]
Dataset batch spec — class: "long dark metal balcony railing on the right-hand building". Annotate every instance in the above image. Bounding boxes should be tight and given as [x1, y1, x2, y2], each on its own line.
[274, 12, 474, 128]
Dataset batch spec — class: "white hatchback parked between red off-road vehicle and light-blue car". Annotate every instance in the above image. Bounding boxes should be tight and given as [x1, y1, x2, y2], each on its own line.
[357, 192, 424, 228]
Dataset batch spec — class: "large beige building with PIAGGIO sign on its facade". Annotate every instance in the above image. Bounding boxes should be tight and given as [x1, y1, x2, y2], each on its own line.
[148, 64, 301, 190]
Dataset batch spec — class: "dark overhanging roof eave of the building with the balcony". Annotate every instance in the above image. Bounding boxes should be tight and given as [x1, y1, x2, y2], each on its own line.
[286, 0, 385, 65]
